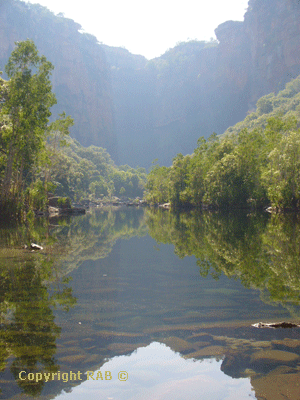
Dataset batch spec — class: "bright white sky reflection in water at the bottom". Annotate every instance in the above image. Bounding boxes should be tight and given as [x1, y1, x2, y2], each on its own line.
[56, 342, 255, 400]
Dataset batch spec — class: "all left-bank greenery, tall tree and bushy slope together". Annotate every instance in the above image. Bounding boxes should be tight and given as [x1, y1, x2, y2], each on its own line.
[0, 40, 145, 219]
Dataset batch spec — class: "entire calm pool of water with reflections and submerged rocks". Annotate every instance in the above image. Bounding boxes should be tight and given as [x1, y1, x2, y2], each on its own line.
[0, 208, 300, 400]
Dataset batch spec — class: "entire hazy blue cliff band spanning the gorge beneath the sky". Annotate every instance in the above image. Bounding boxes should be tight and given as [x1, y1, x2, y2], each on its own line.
[0, 0, 300, 167]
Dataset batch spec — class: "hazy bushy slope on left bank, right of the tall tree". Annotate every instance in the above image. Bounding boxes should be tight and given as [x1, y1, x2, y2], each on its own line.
[46, 137, 146, 201]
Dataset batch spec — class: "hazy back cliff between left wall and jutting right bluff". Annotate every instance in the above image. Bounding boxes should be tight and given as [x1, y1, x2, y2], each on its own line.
[105, 37, 249, 166]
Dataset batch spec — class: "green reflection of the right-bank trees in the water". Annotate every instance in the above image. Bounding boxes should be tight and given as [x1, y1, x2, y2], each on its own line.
[147, 210, 300, 304]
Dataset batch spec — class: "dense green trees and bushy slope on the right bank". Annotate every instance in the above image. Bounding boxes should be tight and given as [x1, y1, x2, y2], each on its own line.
[146, 78, 300, 209]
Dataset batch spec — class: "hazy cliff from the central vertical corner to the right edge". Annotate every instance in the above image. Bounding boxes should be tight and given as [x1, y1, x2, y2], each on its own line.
[104, 0, 300, 165]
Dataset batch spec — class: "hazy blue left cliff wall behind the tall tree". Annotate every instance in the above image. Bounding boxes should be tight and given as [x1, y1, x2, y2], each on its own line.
[0, 0, 117, 156]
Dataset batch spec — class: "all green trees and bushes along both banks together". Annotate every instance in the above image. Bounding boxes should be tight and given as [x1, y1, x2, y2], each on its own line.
[0, 40, 300, 218]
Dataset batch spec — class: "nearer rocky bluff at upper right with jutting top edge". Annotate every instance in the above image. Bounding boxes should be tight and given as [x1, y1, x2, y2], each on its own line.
[215, 0, 300, 109]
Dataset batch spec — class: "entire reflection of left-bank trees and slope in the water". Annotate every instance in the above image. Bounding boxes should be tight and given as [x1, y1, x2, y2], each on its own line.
[0, 209, 147, 395]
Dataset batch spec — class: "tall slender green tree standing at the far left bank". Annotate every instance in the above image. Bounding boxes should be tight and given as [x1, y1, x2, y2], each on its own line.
[0, 40, 56, 216]
